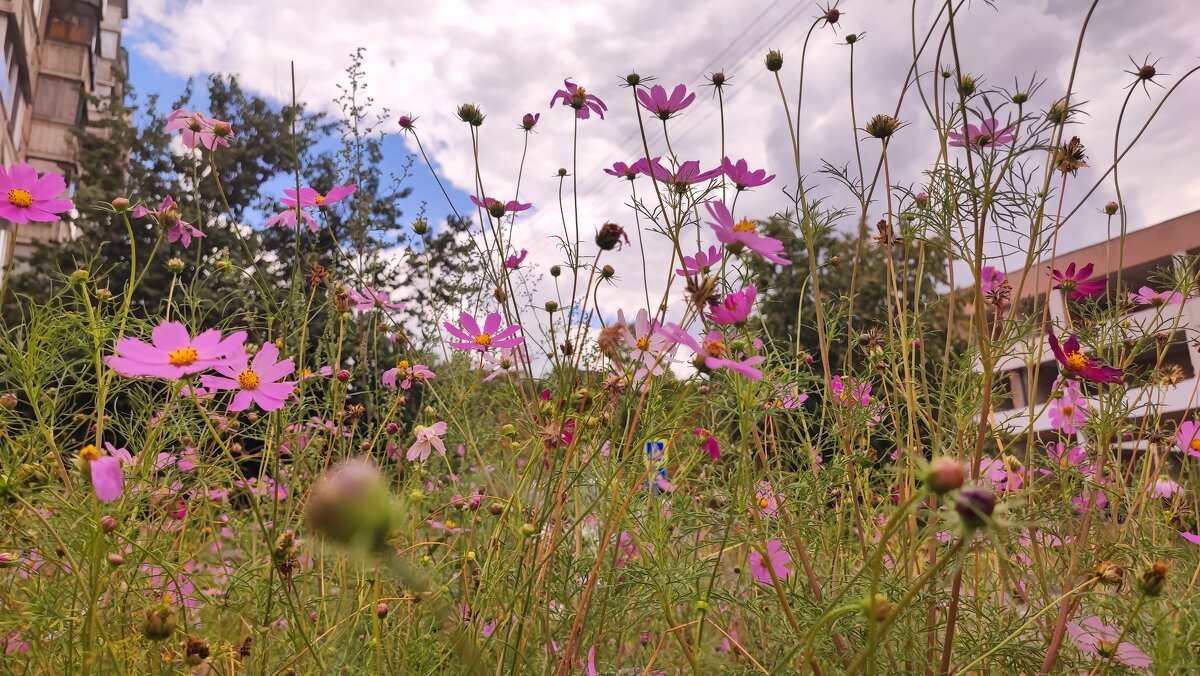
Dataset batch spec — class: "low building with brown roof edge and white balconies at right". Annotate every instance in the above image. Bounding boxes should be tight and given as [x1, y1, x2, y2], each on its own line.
[994, 211, 1200, 433]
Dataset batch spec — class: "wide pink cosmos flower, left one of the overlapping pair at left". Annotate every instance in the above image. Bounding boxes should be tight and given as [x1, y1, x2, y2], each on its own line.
[104, 322, 246, 378]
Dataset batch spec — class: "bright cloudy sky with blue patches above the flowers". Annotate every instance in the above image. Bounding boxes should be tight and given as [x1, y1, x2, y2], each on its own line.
[126, 0, 1200, 312]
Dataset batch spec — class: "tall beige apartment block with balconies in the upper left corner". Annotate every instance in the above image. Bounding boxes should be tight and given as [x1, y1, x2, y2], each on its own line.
[0, 0, 128, 273]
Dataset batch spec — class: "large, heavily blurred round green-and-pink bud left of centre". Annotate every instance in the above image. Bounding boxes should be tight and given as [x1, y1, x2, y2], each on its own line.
[307, 457, 396, 550]
